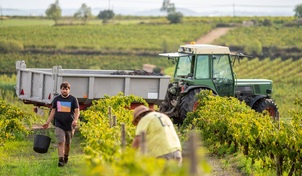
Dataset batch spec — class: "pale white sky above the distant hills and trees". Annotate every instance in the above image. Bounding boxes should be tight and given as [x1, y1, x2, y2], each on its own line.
[0, 0, 302, 16]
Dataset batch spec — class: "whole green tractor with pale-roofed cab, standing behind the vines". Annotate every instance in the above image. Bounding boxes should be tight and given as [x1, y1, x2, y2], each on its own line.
[159, 43, 279, 124]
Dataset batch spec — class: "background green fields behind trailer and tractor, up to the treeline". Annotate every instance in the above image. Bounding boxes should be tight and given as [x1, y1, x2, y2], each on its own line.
[0, 16, 302, 118]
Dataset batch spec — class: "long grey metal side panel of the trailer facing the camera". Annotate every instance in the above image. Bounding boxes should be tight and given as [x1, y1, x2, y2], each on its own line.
[57, 75, 170, 104]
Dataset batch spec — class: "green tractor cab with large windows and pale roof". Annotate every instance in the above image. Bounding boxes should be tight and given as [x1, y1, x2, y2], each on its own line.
[160, 44, 235, 96]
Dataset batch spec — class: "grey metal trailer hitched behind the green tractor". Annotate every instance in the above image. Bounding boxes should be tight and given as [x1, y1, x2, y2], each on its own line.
[15, 61, 171, 110]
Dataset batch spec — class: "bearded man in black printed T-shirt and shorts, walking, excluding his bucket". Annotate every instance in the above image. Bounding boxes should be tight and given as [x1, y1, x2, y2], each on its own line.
[43, 82, 80, 167]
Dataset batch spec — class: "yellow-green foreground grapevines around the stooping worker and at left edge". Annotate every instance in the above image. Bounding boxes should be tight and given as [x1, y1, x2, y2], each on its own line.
[0, 92, 302, 176]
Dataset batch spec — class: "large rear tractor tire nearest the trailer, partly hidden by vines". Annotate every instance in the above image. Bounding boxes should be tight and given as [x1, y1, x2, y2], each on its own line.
[179, 89, 203, 124]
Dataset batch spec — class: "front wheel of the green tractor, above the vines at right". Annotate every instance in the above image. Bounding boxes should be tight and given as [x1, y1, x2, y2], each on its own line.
[255, 99, 279, 120]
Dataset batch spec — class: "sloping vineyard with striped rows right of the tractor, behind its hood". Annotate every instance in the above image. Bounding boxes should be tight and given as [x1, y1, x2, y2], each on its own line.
[234, 58, 302, 118]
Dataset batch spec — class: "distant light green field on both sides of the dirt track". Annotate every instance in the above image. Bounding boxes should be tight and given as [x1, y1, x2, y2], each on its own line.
[0, 17, 294, 51]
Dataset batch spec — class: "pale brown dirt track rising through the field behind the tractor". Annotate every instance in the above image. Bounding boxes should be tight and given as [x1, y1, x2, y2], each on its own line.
[196, 28, 233, 44]
